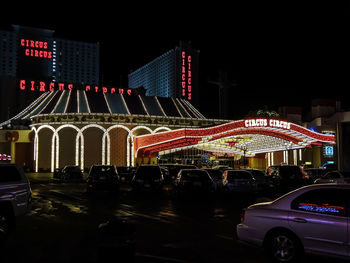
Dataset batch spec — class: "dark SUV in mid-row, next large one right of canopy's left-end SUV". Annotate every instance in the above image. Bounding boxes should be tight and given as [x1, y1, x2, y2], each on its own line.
[174, 169, 214, 195]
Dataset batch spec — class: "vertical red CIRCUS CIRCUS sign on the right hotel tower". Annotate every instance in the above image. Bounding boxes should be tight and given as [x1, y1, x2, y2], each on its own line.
[181, 51, 192, 100]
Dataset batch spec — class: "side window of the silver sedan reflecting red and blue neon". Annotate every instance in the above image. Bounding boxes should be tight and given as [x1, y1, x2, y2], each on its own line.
[291, 189, 346, 219]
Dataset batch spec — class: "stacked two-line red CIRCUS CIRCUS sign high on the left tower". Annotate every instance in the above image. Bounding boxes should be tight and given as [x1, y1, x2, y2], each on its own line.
[20, 38, 52, 59]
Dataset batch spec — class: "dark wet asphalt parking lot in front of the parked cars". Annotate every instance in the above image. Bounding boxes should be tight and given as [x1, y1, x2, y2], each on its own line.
[1, 174, 348, 263]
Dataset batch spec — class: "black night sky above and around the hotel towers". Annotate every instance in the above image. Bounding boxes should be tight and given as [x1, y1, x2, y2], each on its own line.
[1, 1, 350, 119]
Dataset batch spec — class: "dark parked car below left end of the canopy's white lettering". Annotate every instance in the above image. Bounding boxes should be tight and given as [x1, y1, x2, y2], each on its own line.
[222, 170, 257, 193]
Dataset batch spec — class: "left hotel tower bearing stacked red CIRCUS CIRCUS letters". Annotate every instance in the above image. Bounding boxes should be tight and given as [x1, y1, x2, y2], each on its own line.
[0, 25, 99, 121]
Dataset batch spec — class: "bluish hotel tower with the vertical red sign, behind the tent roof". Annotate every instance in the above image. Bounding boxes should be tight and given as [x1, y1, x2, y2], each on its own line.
[128, 42, 199, 106]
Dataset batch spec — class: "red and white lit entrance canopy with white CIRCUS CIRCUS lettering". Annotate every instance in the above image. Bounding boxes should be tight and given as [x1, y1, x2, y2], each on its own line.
[134, 118, 335, 157]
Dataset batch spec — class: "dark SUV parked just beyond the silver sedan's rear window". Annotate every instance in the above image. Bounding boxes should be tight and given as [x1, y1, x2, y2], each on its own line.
[267, 164, 306, 192]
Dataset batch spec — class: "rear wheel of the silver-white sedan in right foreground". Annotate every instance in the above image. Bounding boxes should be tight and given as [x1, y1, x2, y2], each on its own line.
[266, 231, 302, 262]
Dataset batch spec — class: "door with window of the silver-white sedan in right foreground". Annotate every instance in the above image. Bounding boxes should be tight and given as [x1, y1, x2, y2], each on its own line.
[289, 188, 348, 256]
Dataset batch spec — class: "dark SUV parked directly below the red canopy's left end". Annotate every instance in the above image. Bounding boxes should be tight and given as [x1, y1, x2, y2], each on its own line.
[131, 165, 164, 191]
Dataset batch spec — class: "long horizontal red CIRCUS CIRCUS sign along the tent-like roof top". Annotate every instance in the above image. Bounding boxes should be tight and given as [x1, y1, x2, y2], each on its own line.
[19, 79, 133, 95]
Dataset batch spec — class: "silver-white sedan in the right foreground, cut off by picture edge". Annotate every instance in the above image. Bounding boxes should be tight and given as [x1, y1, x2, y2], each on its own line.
[237, 184, 350, 262]
